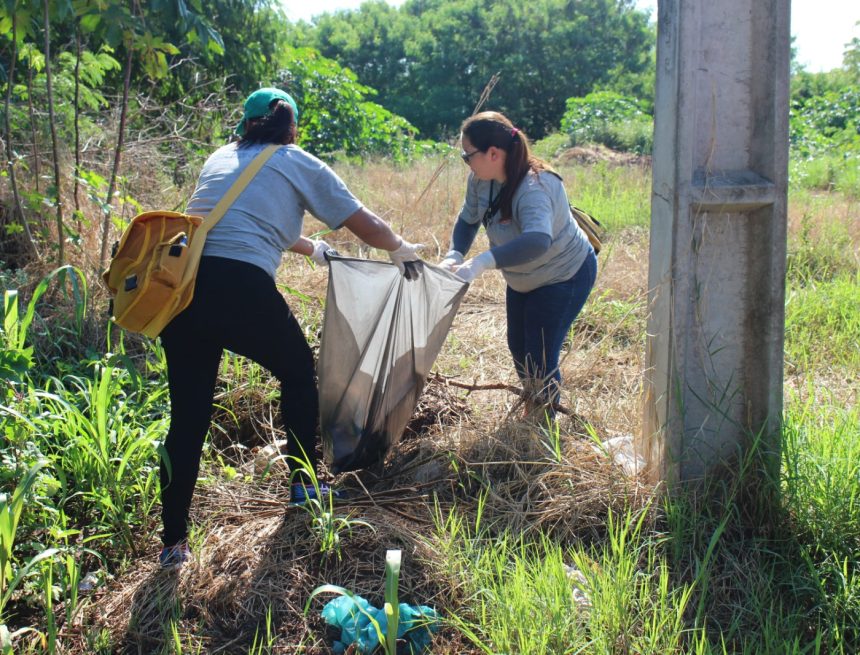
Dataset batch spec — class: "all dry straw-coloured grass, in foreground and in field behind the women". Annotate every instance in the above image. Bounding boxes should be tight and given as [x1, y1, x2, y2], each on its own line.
[60, 156, 648, 653]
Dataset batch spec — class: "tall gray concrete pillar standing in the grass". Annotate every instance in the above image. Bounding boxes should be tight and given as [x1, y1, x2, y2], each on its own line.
[637, 0, 790, 482]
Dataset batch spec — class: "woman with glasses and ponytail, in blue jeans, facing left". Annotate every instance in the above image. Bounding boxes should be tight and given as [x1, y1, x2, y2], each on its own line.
[440, 111, 597, 412]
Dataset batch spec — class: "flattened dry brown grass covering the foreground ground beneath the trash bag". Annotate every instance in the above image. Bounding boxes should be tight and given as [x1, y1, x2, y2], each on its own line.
[81, 379, 646, 653]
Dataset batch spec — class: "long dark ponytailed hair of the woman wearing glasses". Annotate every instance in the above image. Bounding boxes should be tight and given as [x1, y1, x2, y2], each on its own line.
[460, 111, 552, 219]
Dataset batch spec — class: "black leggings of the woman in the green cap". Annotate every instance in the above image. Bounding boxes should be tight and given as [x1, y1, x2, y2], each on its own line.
[161, 257, 319, 546]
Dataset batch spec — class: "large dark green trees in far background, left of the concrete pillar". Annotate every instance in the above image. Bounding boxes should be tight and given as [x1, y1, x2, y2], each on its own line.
[305, 0, 654, 139]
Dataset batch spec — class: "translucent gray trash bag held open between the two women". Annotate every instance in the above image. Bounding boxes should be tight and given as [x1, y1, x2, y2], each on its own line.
[317, 257, 468, 473]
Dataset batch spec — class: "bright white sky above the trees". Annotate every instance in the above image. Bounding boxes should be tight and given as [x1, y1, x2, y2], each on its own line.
[281, 0, 860, 73]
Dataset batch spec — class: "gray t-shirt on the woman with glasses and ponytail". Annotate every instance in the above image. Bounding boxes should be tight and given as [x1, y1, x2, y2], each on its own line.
[458, 171, 591, 293]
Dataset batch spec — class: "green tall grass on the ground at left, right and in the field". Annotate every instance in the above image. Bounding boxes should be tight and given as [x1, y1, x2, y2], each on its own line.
[0, 161, 860, 655]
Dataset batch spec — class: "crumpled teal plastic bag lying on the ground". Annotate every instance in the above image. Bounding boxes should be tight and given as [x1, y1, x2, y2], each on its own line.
[322, 596, 439, 655]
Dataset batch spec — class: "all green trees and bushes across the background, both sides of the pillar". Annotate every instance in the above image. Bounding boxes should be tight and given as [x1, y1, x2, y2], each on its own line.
[0, 0, 860, 270]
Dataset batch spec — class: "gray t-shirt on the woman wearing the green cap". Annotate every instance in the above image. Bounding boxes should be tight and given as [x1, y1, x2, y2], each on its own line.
[185, 143, 362, 277]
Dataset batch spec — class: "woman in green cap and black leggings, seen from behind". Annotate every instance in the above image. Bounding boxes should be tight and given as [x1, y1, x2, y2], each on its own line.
[159, 88, 419, 568]
